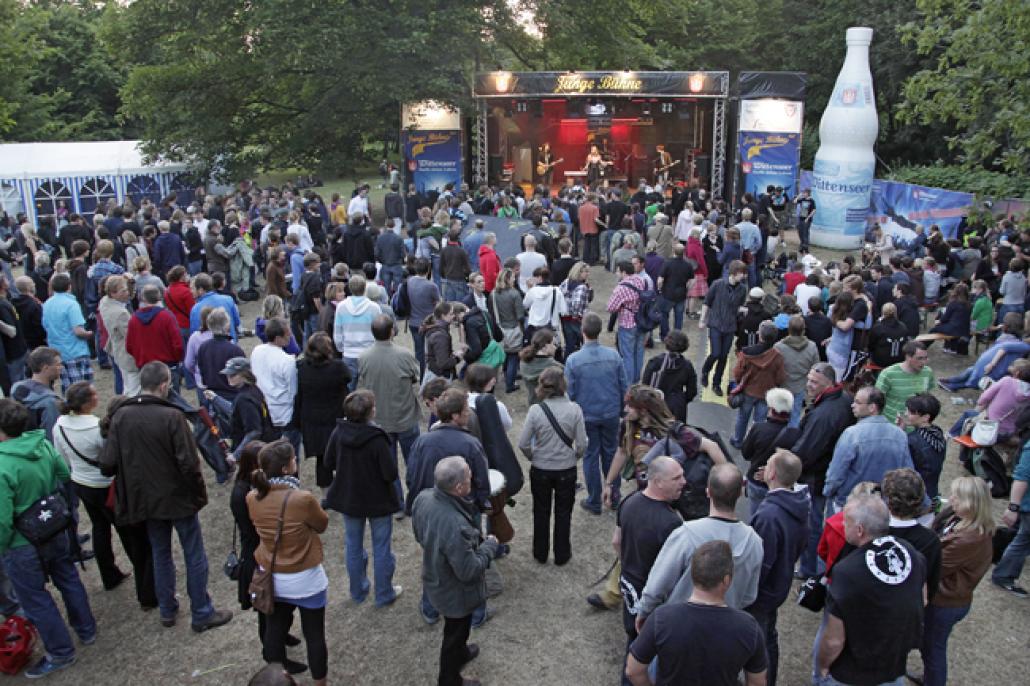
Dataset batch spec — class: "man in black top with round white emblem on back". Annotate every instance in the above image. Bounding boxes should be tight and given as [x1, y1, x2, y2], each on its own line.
[815, 495, 926, 685]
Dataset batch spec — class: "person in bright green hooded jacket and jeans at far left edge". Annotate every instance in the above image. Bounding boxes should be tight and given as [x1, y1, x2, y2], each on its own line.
[0, 399, 97, 679]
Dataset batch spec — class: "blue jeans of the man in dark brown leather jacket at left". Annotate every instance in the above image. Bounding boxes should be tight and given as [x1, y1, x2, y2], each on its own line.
[146, 514, 214, 624]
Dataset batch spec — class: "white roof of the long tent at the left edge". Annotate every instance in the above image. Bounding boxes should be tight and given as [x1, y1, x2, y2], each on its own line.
[0, 140, 190, 178]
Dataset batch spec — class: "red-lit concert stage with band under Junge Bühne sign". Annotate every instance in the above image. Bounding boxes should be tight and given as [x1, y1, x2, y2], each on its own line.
[473, 71, 729, 197]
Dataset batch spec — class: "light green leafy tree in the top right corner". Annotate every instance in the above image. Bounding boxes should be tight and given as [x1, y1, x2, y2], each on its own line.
[899, 0, 1030, 174]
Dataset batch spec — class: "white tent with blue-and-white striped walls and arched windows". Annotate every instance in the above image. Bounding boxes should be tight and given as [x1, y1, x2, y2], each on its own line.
[0, 140, 196, 224]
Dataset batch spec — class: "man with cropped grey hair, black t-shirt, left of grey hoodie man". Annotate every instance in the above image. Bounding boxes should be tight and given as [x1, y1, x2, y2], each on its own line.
[612, 456, 686, 679]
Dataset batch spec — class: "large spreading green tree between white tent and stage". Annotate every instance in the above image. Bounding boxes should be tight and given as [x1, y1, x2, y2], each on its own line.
[103, 0, 531, 177]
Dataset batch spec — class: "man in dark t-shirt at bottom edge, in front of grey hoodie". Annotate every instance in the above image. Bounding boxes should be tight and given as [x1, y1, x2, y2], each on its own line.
[626, 541, 767, 686]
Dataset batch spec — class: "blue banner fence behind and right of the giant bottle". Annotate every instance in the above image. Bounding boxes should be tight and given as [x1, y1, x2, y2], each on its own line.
[800, 171, 973, 239]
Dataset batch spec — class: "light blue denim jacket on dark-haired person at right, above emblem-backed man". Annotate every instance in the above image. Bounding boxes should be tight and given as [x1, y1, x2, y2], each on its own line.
[823, 415, 914, 506]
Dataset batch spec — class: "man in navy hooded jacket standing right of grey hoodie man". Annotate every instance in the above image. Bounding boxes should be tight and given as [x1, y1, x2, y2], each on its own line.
[746, 449, 812, 686]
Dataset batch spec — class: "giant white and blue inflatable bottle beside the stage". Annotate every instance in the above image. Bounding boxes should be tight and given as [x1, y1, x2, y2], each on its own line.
[812, 27, 879, 249]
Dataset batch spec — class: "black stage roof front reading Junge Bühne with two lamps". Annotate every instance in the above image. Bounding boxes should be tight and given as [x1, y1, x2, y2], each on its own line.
[473, 71, 729, 98]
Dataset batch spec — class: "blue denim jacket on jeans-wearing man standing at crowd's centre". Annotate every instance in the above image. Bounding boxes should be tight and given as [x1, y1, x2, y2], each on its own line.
[565, 341, 628, 421]
